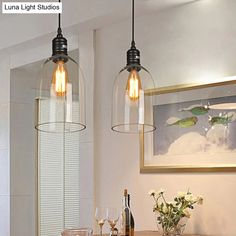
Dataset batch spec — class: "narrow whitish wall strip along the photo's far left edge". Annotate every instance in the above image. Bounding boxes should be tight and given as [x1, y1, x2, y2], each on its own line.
[0, 54, 10, 235]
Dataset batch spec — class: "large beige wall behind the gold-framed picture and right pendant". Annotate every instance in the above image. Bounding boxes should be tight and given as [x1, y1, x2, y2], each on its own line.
[94, 0, 236, 236]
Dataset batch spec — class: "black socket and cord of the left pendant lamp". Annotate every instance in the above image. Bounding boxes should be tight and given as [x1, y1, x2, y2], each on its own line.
[52, 0, 68, 62]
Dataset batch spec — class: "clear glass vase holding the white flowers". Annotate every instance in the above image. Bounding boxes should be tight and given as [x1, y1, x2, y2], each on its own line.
[156, 216, 188, 236]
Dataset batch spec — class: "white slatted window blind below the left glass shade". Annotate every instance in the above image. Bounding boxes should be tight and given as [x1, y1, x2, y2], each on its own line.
[38, 100, 79, 236]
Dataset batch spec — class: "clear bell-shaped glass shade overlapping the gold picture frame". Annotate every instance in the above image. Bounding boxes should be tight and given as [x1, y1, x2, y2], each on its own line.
[112, 64, 156, 133]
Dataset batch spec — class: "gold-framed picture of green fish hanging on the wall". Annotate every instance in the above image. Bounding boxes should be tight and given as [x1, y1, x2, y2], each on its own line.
[140, 80, 236, 173]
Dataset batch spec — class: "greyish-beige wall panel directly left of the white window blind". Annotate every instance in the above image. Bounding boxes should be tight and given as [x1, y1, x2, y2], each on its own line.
[10, 68, 37, 236]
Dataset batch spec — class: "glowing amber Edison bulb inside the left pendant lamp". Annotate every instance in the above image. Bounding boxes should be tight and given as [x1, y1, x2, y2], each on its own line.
[52, 61, 68, 97]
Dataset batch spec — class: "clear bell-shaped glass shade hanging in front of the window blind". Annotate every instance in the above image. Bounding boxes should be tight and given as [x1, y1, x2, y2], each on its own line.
[35, 54, 86, 133]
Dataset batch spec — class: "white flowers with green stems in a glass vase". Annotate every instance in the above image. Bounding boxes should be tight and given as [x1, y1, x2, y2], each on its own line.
[149, 189, 203, 236]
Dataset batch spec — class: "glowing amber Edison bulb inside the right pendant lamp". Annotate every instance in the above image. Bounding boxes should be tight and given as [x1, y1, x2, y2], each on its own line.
[126, 69, 142, 101]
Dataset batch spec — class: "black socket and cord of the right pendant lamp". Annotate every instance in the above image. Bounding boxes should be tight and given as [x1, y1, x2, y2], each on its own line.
[127, 0, 140, 70]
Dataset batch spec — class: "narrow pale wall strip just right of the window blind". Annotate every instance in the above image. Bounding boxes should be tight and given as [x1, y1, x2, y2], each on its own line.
[78, 31, 95, 230]
